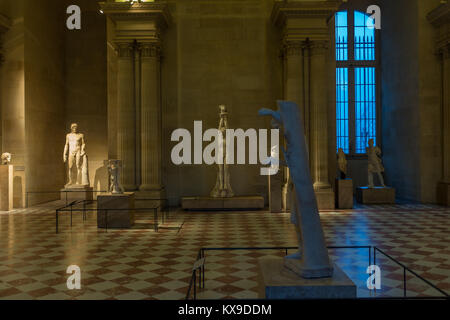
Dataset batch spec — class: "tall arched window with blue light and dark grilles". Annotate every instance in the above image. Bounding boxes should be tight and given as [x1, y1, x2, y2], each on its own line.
[335, 10, 379, 155]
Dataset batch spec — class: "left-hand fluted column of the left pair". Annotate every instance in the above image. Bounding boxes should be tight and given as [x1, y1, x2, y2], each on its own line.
[117, 42, 137, 191]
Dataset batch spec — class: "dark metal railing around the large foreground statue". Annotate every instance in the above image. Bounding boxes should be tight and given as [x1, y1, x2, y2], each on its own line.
[185, 246, 449, 300]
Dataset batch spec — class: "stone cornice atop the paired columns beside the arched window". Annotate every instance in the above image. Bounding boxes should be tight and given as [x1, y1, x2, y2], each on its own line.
[271, 0, 342, 27]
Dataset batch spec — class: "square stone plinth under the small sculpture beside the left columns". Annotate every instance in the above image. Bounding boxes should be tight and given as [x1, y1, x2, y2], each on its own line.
[97, 192, 134, 229]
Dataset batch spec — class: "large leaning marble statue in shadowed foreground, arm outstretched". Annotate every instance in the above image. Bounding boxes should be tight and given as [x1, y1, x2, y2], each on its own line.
[259, 101, 334, 278]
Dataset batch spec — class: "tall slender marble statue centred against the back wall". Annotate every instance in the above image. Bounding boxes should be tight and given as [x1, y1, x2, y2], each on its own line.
[211, 105, 234, 198]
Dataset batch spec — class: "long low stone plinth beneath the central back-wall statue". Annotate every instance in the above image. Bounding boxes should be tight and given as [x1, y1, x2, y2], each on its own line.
[181, 196, 264, 210]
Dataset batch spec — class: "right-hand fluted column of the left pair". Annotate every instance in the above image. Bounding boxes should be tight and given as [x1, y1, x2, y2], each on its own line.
[139, 43, 162, 191]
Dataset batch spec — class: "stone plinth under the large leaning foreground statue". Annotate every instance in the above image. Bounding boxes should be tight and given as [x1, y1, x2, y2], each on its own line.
[258, 258, 356, 300]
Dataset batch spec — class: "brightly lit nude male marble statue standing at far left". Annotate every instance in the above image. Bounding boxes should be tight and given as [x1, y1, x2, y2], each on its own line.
[63, 123, 90, 187]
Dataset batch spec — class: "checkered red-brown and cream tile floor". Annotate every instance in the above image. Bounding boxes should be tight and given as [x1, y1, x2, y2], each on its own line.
[0, 204, 450, 299]
